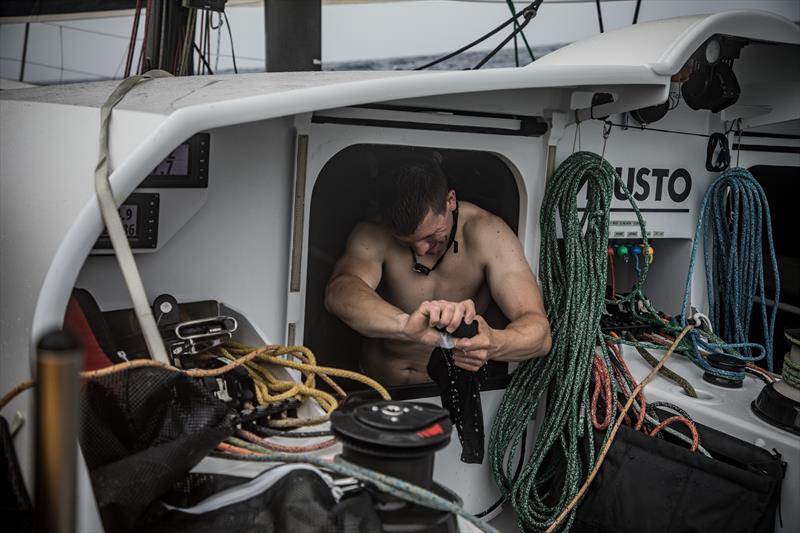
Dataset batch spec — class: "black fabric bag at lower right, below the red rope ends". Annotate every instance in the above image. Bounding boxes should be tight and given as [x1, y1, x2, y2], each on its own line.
[573, 418, 783, 533]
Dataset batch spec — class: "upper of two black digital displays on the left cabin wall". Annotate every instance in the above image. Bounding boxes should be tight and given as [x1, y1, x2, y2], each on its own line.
[141, 133, 211, 188]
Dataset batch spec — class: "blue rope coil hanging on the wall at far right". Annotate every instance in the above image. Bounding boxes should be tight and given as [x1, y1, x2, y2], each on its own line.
[679, 167, 780, 381]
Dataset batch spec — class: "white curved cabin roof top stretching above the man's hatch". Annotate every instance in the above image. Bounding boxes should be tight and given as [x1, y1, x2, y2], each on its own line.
[0, 10, 800, 121]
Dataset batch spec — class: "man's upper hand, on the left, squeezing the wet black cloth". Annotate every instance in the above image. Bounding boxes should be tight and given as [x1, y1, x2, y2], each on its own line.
[403, 300, 476, 347]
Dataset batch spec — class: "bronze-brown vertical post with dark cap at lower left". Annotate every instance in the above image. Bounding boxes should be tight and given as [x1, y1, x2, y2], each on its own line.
[34, 331, 83, 533]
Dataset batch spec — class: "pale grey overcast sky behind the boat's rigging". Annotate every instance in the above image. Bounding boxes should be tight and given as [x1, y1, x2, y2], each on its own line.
[0, 0, 800, 83]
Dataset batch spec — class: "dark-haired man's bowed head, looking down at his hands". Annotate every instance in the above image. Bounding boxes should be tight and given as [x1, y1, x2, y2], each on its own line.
[379, 157, 456, 256]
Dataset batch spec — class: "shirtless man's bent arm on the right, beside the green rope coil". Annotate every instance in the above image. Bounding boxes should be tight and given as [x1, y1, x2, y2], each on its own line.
[454, 216, 551, 370]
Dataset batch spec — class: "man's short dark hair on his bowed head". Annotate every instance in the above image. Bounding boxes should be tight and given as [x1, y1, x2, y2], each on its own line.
[378, 157, 450, 235]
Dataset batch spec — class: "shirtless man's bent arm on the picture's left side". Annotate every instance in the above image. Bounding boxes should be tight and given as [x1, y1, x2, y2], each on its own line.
[325, 222, 450, 346]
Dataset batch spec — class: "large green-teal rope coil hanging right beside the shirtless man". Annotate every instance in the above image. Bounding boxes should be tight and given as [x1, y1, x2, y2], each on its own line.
[489, 152, 624, 530]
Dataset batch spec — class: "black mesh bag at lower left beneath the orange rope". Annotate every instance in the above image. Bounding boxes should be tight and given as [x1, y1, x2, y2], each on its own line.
[80, 368, 233, 531]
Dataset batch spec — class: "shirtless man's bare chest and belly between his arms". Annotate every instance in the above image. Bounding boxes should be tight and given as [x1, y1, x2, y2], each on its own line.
[361, 202, 494, 385]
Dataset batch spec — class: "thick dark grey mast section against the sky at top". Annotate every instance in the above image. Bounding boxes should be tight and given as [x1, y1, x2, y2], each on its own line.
[264, 0, 322, 72]
